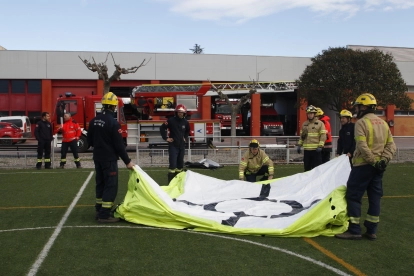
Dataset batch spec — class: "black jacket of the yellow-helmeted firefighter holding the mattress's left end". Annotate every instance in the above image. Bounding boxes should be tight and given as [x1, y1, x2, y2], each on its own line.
[87, 110, 131, 165]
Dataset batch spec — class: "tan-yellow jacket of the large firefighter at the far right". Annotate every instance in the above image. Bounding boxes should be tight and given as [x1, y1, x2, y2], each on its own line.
[352, 113, 396, 166]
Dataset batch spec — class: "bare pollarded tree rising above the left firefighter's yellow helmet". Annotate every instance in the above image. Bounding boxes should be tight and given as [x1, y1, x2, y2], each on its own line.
[78, 52, 151, 95]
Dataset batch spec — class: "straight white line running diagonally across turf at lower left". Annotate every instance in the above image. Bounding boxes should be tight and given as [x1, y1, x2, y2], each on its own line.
[27, 171, 93, 276]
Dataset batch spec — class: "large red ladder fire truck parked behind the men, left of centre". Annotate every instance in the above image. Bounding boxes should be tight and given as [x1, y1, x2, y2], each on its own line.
[52, 84, 220, 152]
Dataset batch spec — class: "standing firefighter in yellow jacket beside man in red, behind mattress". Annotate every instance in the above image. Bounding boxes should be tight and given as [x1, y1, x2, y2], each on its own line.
[297, 105, 326, 172]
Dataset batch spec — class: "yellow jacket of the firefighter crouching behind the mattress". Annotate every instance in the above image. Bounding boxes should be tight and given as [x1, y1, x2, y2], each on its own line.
[239, 149, 274, 179]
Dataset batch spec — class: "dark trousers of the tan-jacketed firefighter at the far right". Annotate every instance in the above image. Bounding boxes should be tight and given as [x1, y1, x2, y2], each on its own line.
[346, 165, 384, 235]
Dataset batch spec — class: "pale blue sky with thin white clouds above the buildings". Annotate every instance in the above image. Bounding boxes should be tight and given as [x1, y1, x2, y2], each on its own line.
[0, 0, 414, 57]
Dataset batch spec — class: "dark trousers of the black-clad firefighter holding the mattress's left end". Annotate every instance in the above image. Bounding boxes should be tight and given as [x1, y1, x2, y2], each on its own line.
[94, 160, 118, 219]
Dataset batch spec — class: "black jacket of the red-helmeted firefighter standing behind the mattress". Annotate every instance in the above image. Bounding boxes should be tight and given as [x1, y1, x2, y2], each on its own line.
[160, 116, 190, 148]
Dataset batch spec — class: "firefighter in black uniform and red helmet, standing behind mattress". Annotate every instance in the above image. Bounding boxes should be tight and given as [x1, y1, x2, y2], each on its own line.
[160, 104, 190, 184]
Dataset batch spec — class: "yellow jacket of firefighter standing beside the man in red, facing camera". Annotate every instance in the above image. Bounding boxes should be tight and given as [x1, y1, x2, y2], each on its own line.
[299, 118, 326, 150]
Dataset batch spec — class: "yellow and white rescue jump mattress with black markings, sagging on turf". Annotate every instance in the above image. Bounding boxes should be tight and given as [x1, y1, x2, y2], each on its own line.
[115, 155, 351, 237]
